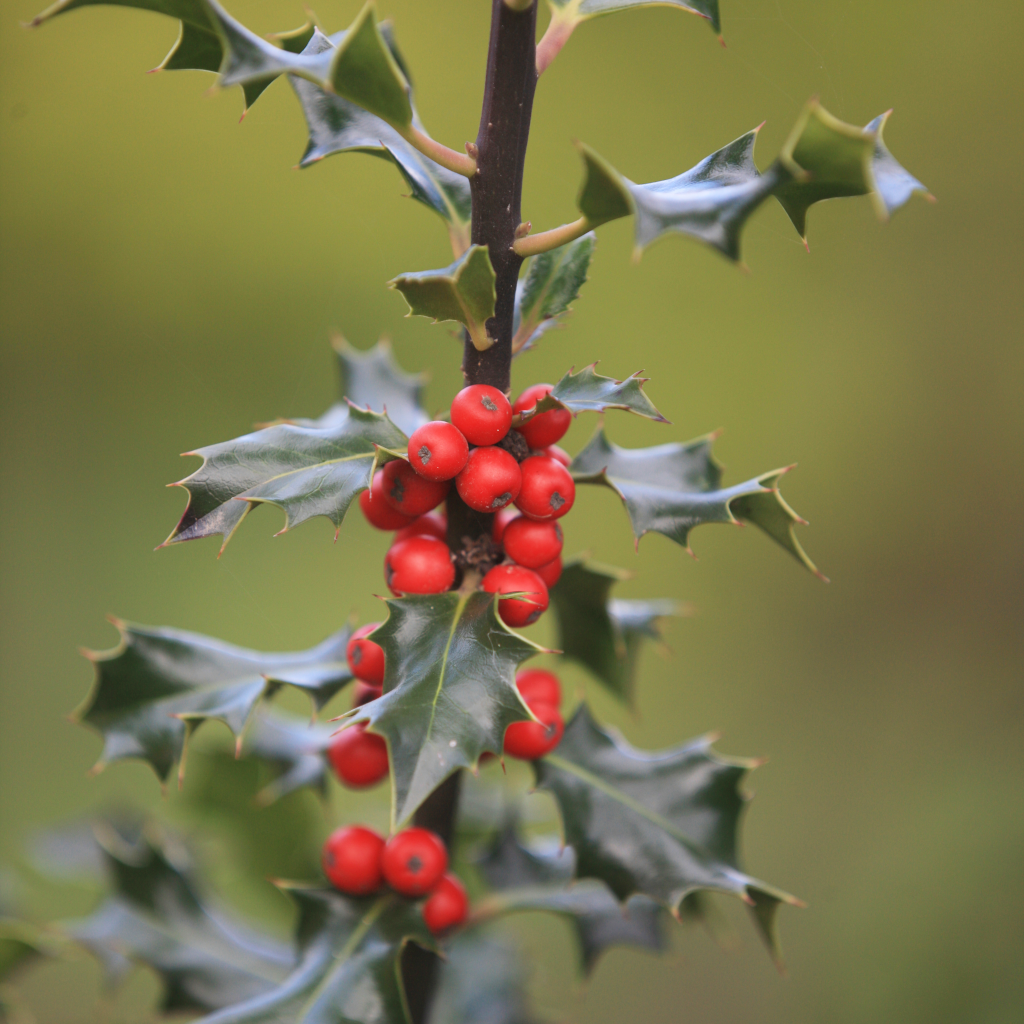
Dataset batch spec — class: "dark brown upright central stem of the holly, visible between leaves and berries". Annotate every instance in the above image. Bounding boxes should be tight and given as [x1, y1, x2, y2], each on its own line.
[401, 6, 537, 1024]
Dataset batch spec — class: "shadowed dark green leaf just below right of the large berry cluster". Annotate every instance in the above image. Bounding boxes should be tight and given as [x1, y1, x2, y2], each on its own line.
[551, 559, 679, 706]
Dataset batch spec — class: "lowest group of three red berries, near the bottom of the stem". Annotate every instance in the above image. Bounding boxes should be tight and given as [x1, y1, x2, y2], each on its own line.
[323, 825, 469, 935]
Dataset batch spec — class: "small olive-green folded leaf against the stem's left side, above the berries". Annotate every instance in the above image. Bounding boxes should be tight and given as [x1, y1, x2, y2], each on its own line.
[388, 246, 497, 352]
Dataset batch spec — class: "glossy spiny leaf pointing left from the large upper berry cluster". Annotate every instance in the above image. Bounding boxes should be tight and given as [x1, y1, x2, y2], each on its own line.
[162, 406, 408, 551]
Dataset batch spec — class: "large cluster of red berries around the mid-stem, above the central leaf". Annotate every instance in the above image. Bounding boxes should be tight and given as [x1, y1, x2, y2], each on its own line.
[353, 384, 575, 626]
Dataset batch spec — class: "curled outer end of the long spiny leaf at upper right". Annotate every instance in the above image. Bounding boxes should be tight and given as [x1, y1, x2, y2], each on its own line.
[775, 99, 929, 242]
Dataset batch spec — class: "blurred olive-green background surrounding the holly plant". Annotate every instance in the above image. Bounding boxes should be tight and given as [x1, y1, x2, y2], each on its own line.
[0, 0, 1024, 1024]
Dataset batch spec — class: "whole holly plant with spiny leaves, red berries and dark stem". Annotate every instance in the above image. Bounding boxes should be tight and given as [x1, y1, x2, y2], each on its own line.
[8, 0, 929, 1024]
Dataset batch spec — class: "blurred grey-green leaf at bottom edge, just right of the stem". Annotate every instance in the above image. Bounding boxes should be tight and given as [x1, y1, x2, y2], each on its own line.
[429, 934, 537, 1024]
